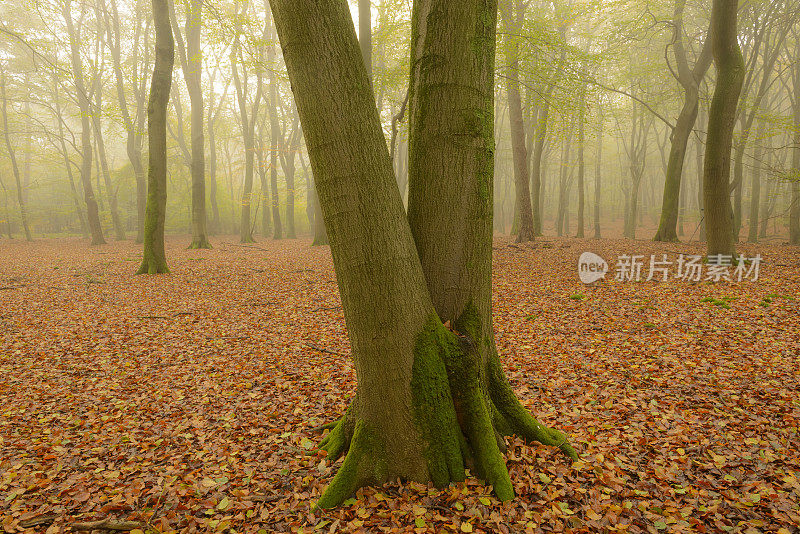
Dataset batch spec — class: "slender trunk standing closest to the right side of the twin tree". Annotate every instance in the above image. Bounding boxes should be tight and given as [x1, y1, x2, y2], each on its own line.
[503, 0, 536, 243]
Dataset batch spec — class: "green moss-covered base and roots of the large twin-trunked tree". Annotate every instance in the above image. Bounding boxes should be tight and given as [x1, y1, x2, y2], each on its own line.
[317, 314, 578, 508]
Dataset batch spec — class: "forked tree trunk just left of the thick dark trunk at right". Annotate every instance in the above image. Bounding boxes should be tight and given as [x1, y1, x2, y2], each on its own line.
[653, 0, 712, 241]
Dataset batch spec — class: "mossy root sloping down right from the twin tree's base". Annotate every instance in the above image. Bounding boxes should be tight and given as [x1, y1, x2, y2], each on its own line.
[488, 353, 578, 460]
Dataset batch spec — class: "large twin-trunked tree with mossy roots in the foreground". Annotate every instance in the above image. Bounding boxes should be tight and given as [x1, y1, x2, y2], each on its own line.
[271, 0, 576, 508]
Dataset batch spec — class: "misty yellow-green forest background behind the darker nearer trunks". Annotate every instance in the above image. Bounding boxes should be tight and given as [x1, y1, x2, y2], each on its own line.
[0, 0, 800, 246]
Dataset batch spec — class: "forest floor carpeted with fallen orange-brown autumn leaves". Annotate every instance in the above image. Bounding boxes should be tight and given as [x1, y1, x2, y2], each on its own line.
[0, 237, 800, 534]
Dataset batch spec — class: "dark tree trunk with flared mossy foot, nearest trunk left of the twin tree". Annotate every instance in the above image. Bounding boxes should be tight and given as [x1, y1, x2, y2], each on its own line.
[137, 0, 175, 274]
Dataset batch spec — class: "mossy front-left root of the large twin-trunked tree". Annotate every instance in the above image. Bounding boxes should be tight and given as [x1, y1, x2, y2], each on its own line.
[316, 420, 386, 509]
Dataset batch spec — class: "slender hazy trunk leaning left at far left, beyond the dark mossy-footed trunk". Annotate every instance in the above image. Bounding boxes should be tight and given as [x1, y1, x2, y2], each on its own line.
[62, 0, 106, 245]
